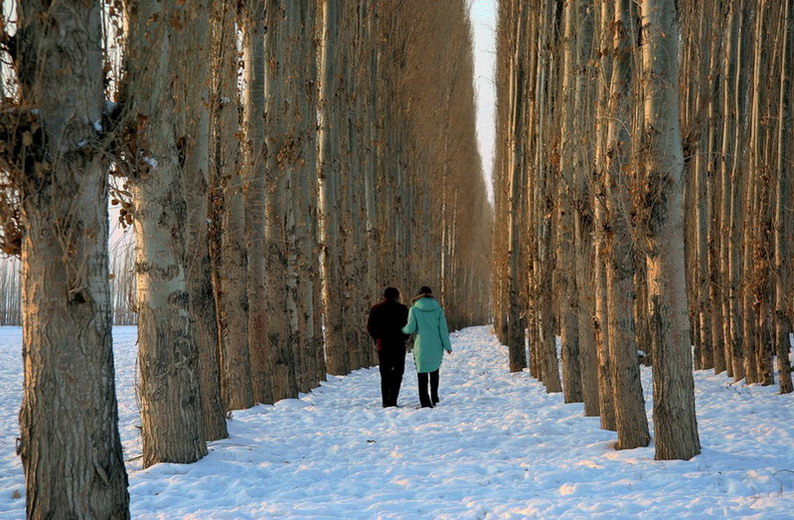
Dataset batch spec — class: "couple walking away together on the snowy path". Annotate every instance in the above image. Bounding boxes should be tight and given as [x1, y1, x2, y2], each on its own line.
[367, 287, 452, 408]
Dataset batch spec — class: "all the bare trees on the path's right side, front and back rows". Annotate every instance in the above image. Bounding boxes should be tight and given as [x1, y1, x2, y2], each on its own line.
[493, 0, 794, 466]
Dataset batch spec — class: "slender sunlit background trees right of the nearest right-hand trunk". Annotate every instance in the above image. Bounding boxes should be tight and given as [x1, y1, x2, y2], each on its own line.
[681, 0, 794, 393]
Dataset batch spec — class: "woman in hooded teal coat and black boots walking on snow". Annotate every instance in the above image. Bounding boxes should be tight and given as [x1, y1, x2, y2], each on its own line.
[403, 287, 452, 408]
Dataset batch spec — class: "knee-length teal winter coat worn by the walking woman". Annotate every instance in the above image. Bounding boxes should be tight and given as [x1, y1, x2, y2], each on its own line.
[403, 297, 452, 373]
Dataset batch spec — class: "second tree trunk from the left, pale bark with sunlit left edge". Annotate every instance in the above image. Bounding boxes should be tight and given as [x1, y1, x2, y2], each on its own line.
[127, 0, 207, 467]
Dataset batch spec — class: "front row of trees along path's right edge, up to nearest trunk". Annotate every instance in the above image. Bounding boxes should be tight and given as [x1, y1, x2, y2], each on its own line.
[493, 0, 748, 459]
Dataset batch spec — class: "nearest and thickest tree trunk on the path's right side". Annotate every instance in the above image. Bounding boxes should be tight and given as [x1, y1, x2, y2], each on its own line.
[642, 0, 700, 460]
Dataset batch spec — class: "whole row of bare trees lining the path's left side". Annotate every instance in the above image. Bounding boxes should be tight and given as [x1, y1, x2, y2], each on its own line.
[0, 0, 492, 518]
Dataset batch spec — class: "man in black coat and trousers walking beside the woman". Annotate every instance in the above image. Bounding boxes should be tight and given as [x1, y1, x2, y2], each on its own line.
[367, 287, 408, 408]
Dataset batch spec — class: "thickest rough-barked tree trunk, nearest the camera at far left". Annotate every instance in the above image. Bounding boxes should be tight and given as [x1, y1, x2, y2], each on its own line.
[15, 0, 129, 519]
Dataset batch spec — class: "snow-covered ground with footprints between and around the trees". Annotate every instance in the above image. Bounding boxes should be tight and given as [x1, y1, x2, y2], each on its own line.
[0, 327, 794, 520]
